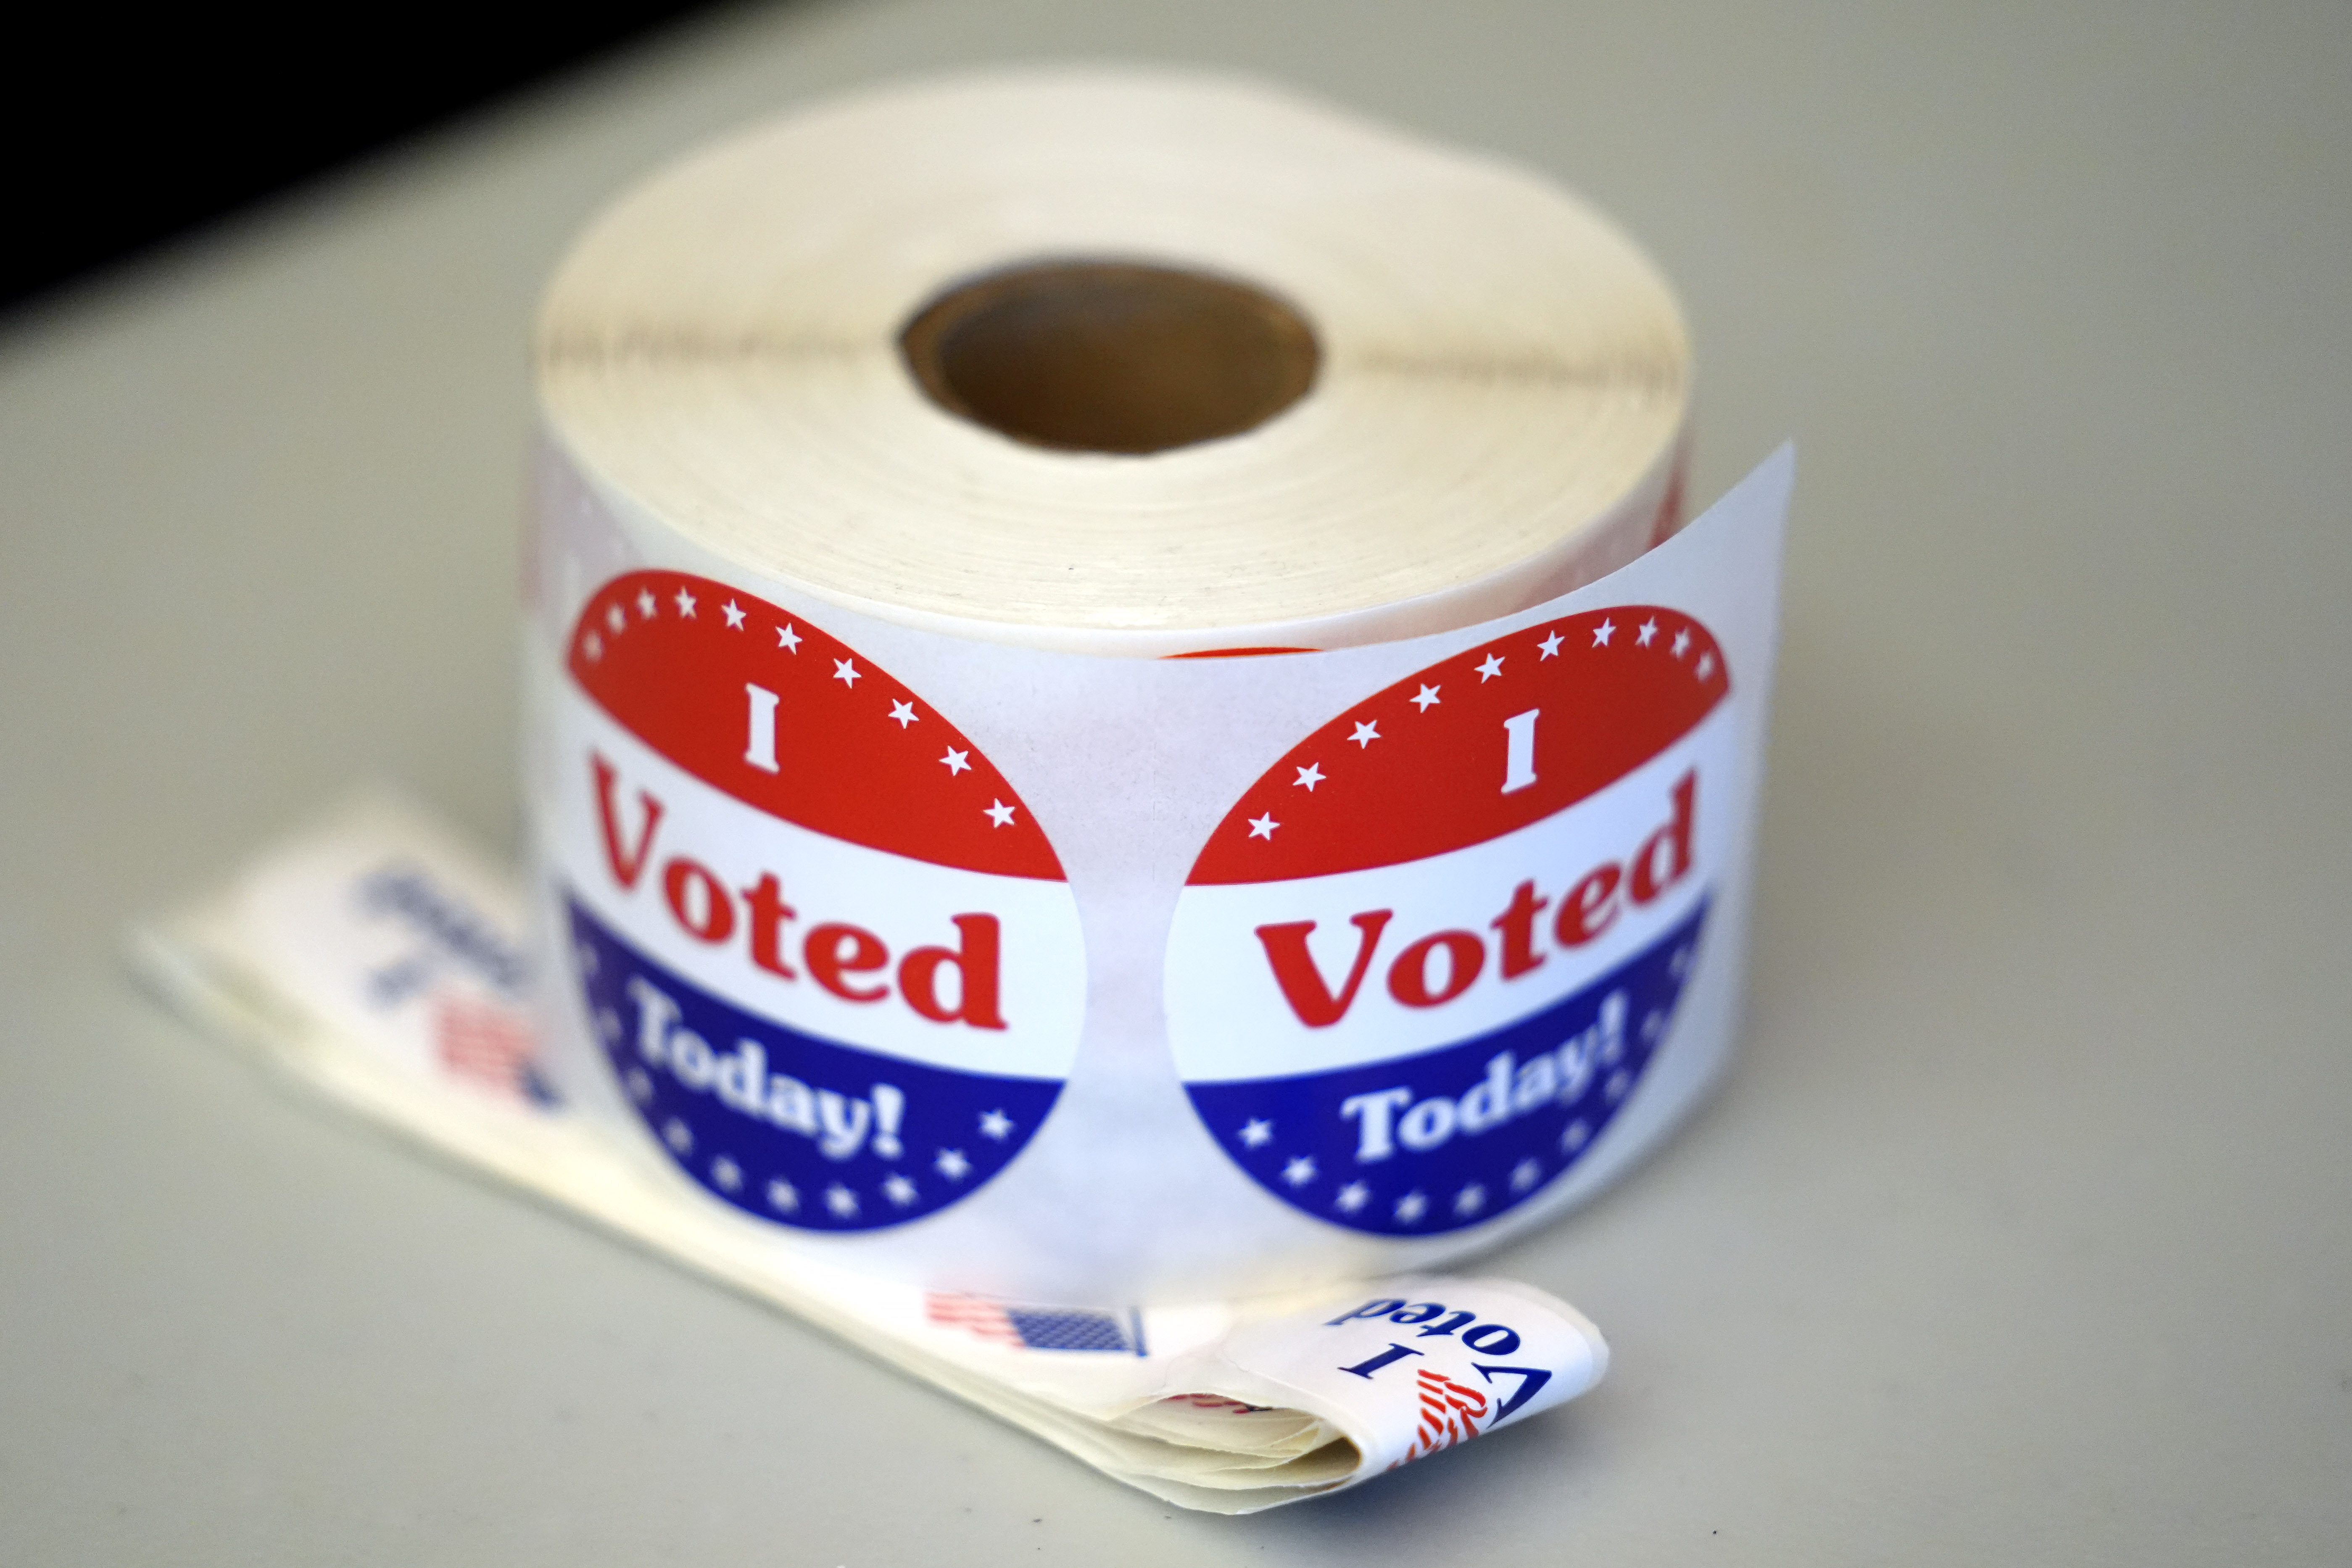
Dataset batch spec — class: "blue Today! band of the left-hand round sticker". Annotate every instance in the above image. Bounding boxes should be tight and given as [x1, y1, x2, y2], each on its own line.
[567, 900, 1061, 1232]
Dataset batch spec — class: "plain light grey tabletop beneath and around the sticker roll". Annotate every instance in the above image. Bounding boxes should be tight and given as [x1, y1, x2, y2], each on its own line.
[0, 0, 2352, 1568]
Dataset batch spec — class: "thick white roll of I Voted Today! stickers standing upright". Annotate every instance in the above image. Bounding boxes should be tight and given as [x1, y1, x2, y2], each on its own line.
[527, 73, 1722, 1302]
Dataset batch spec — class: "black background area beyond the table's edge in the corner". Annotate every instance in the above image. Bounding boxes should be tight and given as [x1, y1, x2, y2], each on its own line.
[0, 0, 733, 310]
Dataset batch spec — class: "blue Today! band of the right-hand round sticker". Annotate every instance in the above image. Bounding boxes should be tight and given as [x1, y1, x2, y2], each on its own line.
[1185, 900, 1708, 1236]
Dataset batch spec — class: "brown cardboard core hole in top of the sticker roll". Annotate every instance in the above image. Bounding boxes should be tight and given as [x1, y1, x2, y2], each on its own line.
[899, 261, 1322, 454]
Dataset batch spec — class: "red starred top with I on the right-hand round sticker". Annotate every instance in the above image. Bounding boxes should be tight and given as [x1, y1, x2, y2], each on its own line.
[1188, 604, 1731, 886]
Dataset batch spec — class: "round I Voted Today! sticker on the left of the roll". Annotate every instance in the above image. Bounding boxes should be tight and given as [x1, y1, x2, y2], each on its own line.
[555, 571, 1086, 1232]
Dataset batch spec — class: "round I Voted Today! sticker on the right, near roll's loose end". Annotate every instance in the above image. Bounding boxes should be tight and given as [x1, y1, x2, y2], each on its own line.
[1167, 604, 1738, 1236]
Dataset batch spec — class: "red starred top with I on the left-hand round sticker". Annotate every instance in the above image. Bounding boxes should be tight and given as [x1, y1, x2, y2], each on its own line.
[567, 571, 1063, 882]
